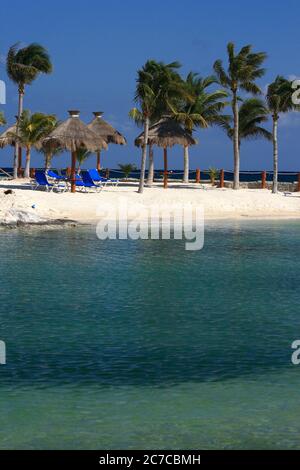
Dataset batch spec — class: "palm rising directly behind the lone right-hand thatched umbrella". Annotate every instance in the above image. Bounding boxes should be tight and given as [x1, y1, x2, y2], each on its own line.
[171, 72, 228, 183]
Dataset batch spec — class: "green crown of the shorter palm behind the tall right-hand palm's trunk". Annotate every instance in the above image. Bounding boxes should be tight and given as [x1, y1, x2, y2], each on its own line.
[223, 98, 272, 149]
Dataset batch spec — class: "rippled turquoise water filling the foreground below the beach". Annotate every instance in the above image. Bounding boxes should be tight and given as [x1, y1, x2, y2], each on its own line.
[0, 221, 300, 449]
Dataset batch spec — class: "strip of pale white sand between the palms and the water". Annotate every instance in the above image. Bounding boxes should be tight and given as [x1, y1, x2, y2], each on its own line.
[0, 181, 300, 222]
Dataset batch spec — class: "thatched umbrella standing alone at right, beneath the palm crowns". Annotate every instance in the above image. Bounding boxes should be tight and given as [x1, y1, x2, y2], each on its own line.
[134, 117, 197, 188]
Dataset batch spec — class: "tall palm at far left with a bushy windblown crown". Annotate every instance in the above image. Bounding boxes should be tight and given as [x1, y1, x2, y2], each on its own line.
[6, 43, 52, 178]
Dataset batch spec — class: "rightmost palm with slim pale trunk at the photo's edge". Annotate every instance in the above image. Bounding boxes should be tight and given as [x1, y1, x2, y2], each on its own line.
[266, 76, 299, 194]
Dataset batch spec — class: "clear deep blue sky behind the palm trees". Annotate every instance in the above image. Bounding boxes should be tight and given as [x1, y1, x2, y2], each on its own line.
[0, 0, 300, 170]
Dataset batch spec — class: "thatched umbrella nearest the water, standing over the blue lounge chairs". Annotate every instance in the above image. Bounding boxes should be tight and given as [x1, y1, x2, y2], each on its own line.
[42, 110, 107, 193]
